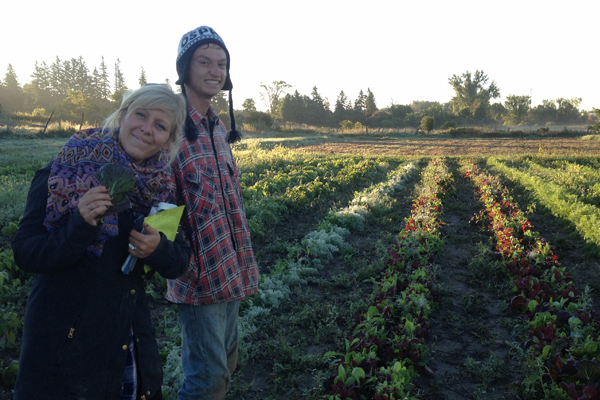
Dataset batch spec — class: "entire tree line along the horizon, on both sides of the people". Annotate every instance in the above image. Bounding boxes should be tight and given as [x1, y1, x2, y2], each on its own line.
[0, 57, 595, 128]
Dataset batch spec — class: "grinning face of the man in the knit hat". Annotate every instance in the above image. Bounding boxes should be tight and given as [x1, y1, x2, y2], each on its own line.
[186, 44, 227, 99]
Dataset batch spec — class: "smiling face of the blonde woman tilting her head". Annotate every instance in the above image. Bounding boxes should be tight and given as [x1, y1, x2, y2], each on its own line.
[119, 108, 173, 165]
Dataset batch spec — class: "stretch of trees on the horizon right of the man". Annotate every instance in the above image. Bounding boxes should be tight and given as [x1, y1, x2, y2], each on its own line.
[253, 70, 597, 130]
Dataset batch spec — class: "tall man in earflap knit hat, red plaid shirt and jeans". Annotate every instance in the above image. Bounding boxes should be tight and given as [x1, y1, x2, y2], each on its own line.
[167, 26, 258, 400]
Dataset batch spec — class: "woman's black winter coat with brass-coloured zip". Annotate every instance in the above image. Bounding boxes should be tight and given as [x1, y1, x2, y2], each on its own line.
[12, 164, 191, 400]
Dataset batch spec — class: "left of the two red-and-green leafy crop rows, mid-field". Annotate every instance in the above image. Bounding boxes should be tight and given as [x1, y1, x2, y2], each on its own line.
[325, 160, 452, 400]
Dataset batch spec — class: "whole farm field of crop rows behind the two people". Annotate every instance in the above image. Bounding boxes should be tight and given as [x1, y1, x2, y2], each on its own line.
[0, 133, 600, 400]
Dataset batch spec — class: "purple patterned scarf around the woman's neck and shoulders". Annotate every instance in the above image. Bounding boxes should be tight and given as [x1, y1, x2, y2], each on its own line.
[44, 128, 173, 257]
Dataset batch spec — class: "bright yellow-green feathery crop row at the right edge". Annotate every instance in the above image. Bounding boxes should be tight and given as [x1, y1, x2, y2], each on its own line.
[487, 157, 600, 255]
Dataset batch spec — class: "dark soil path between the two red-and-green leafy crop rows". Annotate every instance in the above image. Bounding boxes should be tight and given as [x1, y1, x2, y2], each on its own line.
[418, 163, 519, 400]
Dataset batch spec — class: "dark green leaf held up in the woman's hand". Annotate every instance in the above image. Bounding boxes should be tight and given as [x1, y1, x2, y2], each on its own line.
[96, 163, 135, 214]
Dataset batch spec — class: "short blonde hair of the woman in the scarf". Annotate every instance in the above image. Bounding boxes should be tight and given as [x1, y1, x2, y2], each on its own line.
[104, 83, 187, 164]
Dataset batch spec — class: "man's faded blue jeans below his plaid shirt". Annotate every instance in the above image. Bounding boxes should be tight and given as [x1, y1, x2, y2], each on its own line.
[177, 301, 240, 400]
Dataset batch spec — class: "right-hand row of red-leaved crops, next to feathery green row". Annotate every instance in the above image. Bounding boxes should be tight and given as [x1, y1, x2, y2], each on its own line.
[463, 162, 600, 400]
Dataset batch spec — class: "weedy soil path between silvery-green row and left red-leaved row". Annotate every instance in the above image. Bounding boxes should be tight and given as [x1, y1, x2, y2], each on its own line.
[226, 163, 418, 400]
